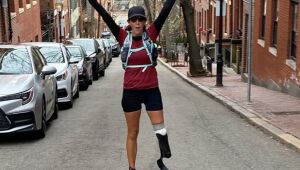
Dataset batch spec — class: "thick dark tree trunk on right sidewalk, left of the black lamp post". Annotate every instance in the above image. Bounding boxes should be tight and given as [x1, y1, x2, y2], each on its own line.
[180, 0, 206, 76]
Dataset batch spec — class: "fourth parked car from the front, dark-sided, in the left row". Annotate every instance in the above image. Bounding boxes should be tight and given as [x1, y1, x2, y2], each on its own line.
[68, 38, 105, 80]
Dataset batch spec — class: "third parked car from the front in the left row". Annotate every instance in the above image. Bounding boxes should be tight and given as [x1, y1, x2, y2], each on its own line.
[66, 45, 93, 90]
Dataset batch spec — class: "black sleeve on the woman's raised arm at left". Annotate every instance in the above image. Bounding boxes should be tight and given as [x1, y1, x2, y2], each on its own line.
[89, 0, 120, 39]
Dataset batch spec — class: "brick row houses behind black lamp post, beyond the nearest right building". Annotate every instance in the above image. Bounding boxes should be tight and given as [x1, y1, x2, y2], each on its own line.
[193, 0, 246, 73]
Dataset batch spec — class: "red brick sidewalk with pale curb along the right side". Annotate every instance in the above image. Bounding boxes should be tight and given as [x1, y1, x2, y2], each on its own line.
[159, 58, 300, 152]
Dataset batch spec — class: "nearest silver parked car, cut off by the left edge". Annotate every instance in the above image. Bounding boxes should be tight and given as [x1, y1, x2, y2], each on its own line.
[0, 45, 58, 138]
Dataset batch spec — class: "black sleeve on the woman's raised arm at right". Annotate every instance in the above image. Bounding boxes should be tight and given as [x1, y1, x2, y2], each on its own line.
[154, 0, 176, 32]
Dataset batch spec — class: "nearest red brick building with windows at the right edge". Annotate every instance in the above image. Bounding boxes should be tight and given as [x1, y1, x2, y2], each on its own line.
[253, 0, 300, 97]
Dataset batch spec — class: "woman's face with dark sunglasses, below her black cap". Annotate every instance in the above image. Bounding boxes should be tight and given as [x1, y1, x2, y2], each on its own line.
[128, 16, 146, 36]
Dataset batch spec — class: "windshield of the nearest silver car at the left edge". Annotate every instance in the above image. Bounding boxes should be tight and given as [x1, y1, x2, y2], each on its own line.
[0, 48, 33, 74]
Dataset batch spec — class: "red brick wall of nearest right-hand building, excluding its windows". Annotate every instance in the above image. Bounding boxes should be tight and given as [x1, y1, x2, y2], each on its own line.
[252, 0, 300, 96]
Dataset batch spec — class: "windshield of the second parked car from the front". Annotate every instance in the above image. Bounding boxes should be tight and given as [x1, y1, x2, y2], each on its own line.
[40, 47, 65, 63]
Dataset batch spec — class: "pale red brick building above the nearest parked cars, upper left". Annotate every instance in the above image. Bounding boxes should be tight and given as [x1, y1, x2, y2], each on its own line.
[7, 0, 42, 43]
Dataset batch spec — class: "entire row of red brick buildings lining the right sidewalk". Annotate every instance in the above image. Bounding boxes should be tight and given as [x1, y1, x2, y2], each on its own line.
[192, 0, 300, 96]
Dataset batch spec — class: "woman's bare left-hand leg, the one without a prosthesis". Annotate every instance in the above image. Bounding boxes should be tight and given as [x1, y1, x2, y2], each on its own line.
[125, 110, 141, 168]
